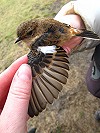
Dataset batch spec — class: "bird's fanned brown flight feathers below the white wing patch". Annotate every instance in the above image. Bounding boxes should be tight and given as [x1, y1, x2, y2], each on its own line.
[28, 47, 69, 117]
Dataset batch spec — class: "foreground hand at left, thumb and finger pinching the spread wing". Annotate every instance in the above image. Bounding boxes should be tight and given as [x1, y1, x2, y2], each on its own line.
[0, 55, 32, 133]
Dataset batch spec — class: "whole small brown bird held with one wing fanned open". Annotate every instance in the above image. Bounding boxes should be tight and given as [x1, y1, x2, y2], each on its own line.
[15, 18, 100, 117]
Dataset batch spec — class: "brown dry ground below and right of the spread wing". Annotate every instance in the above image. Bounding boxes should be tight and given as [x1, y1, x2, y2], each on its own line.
[29, 51, 100, 133]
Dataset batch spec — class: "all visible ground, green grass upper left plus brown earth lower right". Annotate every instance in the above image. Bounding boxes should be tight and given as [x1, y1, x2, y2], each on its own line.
[0, 0, 100, 133]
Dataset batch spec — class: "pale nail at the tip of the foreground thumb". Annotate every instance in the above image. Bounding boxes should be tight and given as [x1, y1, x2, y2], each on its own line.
[17, 64, 32, 80]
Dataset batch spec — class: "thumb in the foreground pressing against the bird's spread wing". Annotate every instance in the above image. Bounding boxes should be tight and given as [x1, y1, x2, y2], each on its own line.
[1, 64, 32, 132]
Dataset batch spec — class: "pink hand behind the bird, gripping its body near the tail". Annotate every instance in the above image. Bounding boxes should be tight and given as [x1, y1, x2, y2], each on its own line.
[54, 4, 85, 53]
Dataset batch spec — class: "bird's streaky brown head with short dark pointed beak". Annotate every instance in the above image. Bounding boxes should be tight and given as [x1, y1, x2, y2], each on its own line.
[15, 20, 39, 46]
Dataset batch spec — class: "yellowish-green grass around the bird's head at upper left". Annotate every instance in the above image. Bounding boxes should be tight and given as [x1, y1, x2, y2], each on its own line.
[0, 0, 64, 72]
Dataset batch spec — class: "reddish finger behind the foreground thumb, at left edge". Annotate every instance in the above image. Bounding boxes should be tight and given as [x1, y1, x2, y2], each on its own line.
[0, 55, 28, 108]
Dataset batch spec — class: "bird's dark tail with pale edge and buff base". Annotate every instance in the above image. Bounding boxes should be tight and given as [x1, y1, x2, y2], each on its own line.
[71, 28, 100, 40]
